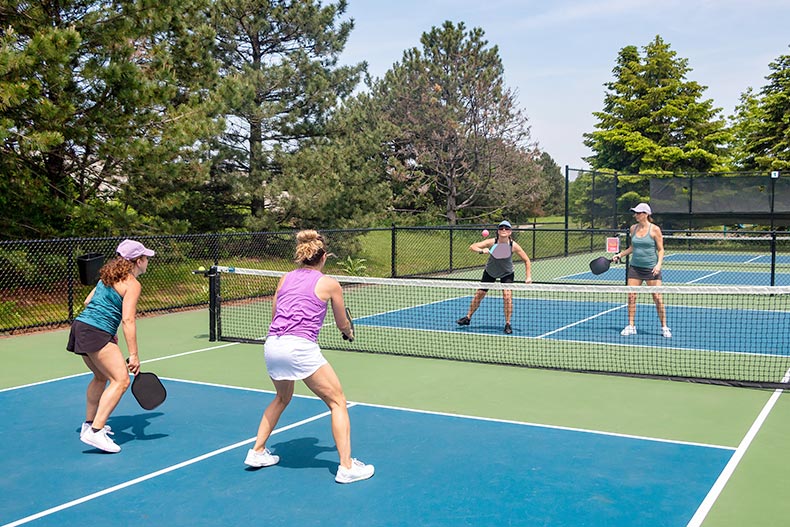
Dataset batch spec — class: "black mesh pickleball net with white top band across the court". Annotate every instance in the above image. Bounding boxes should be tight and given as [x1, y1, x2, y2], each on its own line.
[208, 266, 790, 388]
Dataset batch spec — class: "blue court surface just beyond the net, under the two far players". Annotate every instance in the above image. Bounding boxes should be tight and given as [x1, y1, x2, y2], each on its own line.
[354, 296, 790, 355]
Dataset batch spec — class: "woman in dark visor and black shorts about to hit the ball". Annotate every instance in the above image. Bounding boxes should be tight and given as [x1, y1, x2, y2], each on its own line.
[456, 220, 532, 335]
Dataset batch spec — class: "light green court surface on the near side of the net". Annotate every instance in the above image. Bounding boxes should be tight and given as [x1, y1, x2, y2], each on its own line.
[0, 310, 790, 527]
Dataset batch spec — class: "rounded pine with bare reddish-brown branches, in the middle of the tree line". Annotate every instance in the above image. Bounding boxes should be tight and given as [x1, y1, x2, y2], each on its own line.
[373, 21, 542, 225]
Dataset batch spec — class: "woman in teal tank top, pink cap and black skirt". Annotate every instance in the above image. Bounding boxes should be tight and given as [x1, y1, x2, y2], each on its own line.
[66, 240, 154, 452]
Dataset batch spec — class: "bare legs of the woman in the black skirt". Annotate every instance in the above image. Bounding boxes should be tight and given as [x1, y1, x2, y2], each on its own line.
[82, 342, 129, 430]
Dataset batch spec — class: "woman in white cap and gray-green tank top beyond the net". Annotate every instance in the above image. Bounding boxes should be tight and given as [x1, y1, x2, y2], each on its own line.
[613, 203, 672, 338]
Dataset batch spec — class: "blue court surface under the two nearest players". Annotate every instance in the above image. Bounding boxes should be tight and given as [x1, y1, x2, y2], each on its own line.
[0, 375, 734, 527]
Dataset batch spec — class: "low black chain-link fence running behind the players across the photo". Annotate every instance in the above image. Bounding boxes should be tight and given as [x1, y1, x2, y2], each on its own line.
[0, 224, 790, 333]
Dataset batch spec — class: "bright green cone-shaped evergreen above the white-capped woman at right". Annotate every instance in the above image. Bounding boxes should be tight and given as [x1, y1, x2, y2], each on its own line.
[584, 36, 728, 173]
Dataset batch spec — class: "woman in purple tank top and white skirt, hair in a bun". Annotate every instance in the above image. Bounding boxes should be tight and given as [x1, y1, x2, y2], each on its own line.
[244, 230, 374, 483]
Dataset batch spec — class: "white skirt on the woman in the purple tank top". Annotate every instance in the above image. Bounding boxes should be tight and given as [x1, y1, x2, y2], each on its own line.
[263, 335, 327, 381]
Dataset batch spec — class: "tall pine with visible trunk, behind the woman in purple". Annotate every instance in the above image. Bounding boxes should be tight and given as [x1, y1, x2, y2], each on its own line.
[212, 0, 364, 229]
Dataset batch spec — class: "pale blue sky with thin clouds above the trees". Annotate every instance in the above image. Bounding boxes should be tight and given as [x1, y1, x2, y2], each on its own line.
[340, 0, 790, 169]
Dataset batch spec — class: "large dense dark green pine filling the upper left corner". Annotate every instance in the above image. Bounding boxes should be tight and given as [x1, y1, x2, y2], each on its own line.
[0, 0, 223, 237]
